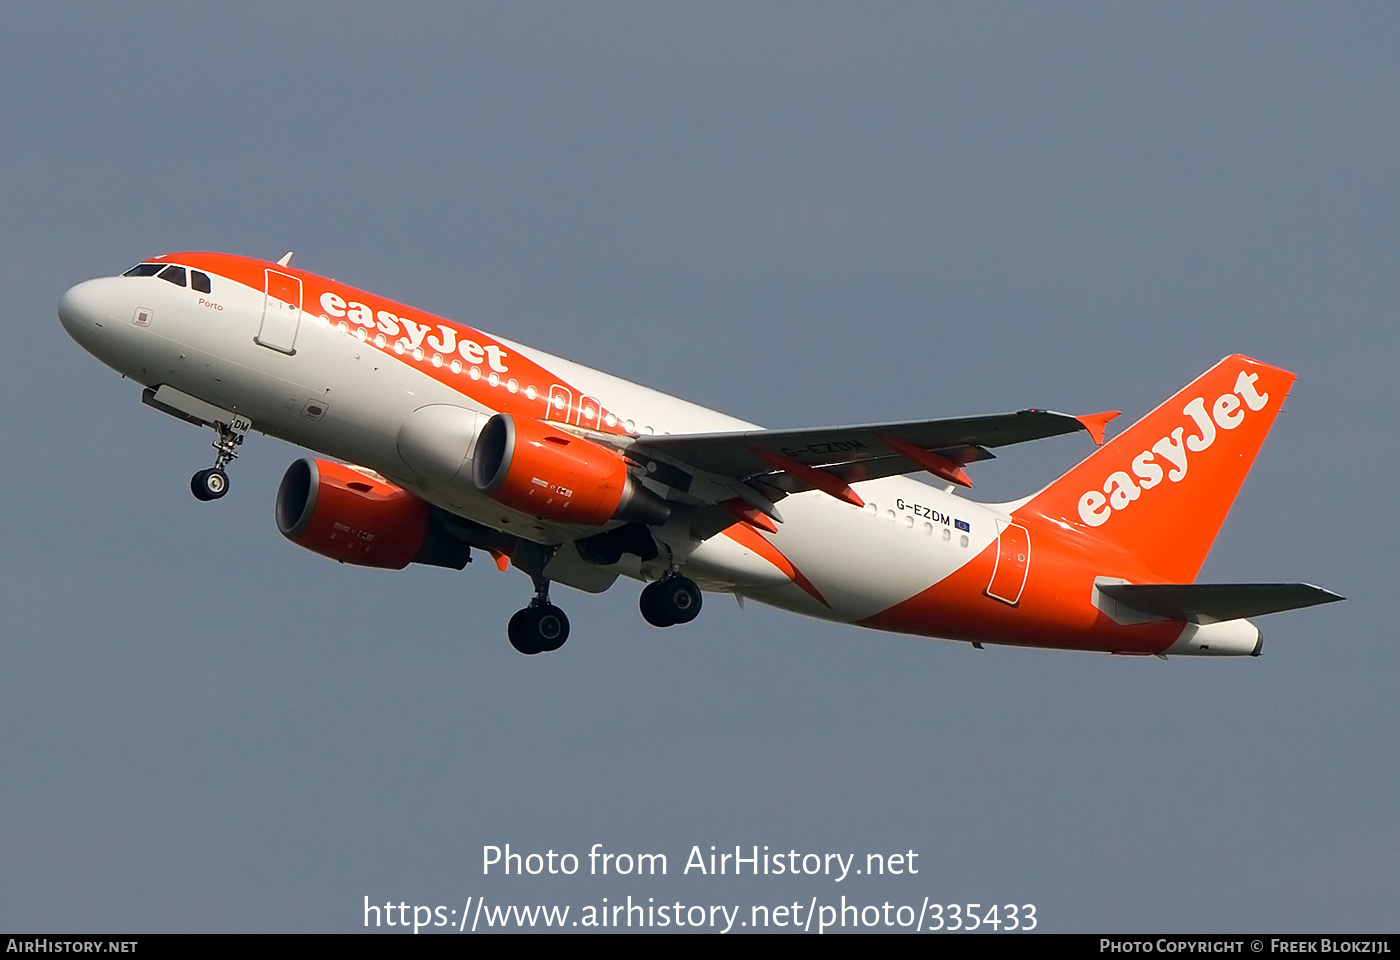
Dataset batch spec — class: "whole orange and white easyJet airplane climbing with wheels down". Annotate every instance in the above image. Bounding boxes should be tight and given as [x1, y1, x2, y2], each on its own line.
[57, 252, 1343, 658]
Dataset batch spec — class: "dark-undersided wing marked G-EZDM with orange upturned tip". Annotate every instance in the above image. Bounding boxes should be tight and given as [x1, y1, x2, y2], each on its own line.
[629, 410, 1117, 500]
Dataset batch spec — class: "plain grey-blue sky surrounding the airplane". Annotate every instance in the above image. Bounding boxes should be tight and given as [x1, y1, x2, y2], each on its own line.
[0, 3, 1400, 931]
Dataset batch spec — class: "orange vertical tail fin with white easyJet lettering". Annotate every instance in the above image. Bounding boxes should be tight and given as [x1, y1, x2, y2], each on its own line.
[1015, 354, 1296, 584]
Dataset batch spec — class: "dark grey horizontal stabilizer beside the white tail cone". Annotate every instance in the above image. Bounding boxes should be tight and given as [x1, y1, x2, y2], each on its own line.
[1098, 584, 1347, 623]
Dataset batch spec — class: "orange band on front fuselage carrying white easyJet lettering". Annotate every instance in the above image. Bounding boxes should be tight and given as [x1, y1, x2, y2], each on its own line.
[151, 252, 627, 434]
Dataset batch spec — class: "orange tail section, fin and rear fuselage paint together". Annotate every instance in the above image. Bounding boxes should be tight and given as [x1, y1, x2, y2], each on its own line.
[862, 354, 1294, 654]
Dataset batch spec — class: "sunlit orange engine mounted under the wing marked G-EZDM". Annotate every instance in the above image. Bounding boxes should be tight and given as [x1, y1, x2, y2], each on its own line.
[472, 413, 671, 526]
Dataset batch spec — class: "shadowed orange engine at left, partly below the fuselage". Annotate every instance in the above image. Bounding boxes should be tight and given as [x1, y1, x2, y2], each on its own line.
[274, 459, 470, 570]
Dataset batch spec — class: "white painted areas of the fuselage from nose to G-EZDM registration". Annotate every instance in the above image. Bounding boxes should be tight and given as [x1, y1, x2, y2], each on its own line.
[60, 267, 1009, 632]
